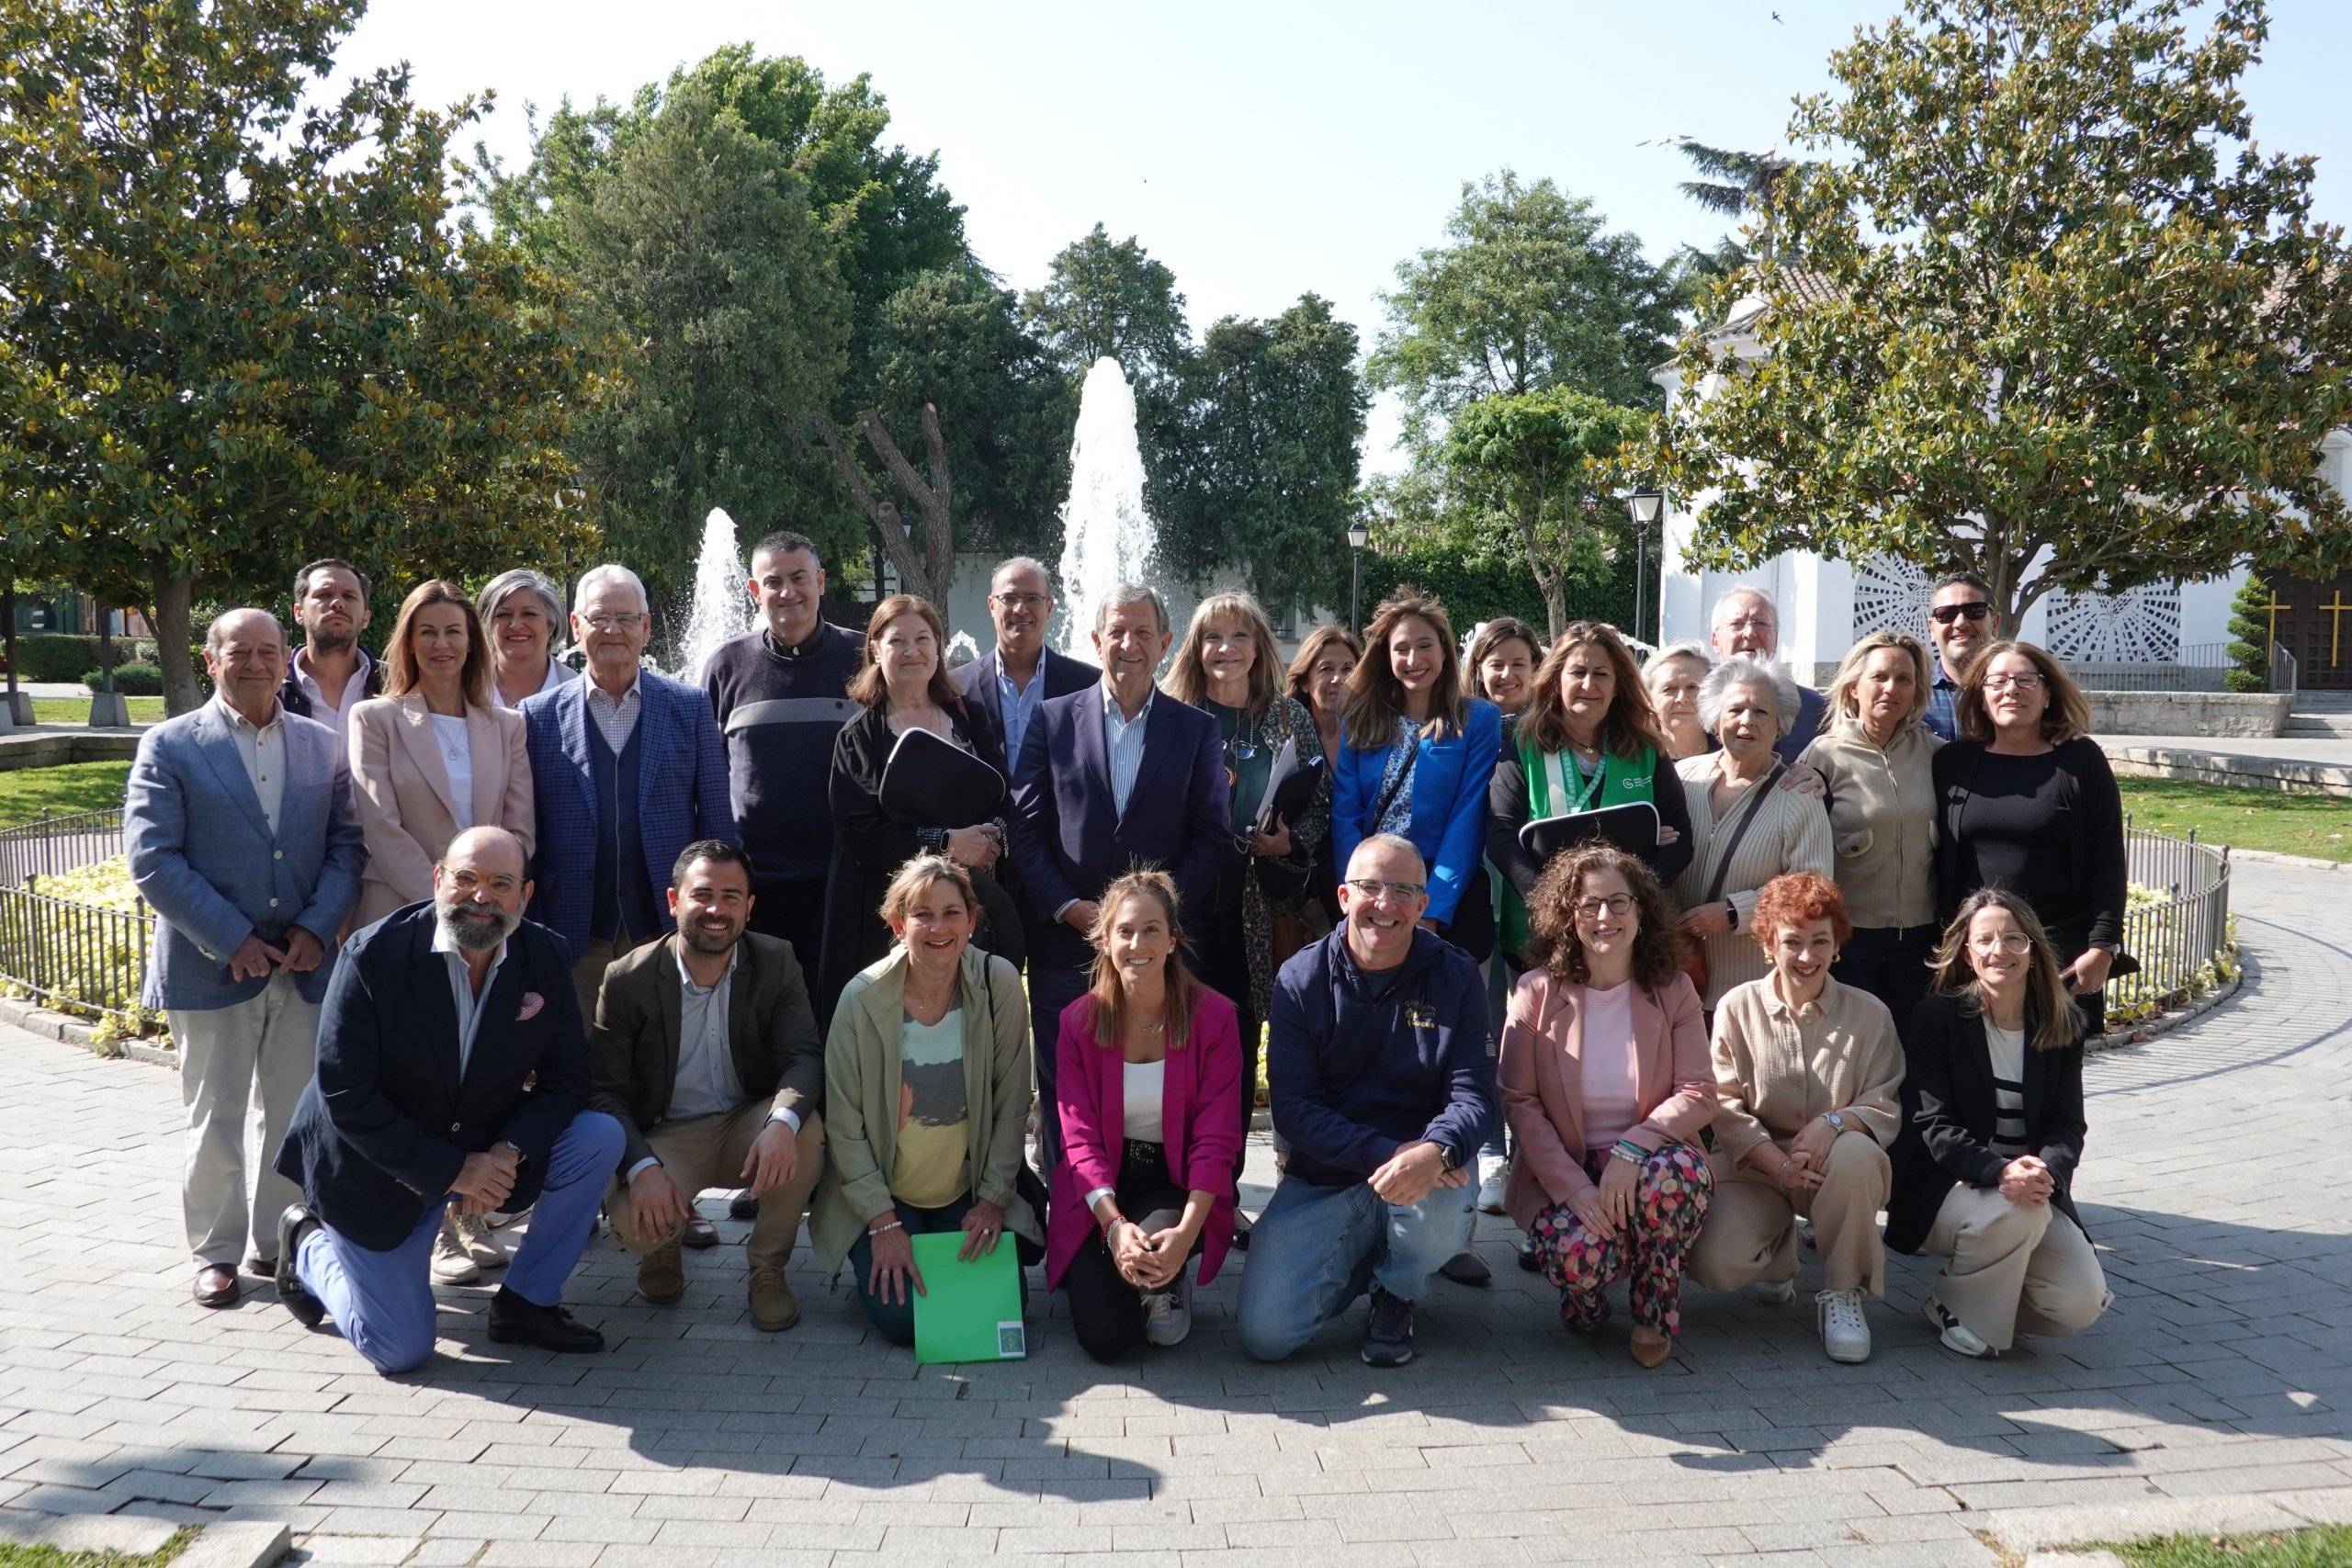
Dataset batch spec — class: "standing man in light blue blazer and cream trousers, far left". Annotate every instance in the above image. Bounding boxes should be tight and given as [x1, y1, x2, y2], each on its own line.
[122, 609, 367, 1307]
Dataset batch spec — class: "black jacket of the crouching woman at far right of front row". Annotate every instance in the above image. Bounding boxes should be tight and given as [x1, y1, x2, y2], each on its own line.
[1886, 995, 2088, 1253]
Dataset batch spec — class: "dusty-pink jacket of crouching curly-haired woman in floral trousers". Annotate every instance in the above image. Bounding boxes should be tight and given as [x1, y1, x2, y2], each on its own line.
[1496, 968, 1714, 1229]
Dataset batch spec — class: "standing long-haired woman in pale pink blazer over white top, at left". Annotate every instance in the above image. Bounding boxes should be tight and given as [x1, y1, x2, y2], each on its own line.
[350, 581, 537, 926]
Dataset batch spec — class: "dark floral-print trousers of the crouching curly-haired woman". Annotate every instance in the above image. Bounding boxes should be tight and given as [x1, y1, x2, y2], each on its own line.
[1532, 1143, 1714, 1340]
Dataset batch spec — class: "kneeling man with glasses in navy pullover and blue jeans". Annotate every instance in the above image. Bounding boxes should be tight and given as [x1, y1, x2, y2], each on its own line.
[1238, 832, 1496, 1366]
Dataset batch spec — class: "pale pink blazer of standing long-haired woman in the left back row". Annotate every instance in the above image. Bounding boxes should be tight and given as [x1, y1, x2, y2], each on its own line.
[350, 691, 537, 926]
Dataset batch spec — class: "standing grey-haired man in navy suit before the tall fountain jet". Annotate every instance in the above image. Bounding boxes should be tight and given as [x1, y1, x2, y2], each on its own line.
[1012, 583, 1230, 1170]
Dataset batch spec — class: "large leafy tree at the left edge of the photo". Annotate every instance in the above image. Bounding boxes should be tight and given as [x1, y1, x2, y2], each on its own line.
[0, 0, 593, 712]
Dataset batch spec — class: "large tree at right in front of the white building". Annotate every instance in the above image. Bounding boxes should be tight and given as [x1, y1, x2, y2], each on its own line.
[1651, 0, 2352, 623]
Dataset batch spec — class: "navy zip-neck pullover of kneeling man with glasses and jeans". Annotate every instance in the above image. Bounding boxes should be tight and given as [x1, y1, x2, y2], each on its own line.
[1265, 926, 1498, 1187]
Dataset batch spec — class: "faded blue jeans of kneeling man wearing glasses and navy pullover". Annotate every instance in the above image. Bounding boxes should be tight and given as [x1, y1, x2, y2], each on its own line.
[1235, 1176, 1477, 1361]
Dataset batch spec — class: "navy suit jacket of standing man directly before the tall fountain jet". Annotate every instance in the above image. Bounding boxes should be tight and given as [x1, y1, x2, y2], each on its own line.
[1009, 682, 1232, 968]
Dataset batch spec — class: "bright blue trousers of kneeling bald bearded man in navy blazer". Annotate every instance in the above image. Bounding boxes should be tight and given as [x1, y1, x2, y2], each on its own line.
[294, 1110, 623, 1373]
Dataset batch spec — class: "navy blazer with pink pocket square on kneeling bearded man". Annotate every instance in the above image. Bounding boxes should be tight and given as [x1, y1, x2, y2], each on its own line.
[277, 903, 591, 1253]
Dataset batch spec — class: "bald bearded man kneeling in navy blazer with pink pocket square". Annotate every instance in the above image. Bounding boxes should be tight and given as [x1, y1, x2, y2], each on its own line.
[277, 828, 623, 1373]
